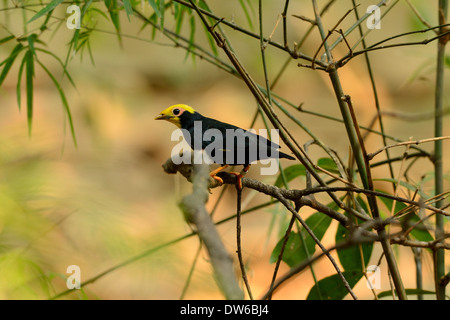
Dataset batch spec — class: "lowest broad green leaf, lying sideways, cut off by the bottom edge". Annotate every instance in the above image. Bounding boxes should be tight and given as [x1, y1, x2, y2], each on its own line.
[306, 270, 364, 300]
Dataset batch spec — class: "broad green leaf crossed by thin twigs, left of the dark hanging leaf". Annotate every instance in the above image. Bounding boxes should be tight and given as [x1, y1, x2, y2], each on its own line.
[270, 212, 331, 268]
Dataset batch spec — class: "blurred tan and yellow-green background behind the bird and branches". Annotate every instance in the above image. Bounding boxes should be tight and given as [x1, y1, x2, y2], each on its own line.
[0, 1, 450, 299]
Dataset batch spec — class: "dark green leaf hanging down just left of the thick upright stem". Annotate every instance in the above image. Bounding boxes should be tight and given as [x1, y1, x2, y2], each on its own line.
[335, 197, 373, 272]
